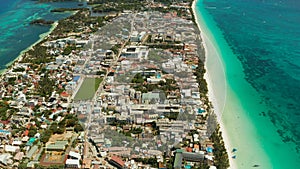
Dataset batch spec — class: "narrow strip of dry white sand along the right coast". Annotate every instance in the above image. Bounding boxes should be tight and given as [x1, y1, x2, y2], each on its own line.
[192, 0, 237, 169]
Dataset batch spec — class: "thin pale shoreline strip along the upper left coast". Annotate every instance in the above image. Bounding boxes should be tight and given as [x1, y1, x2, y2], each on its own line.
[0, 21, 58, 76]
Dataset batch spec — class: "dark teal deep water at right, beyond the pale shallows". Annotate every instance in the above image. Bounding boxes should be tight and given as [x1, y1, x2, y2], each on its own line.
[204, 0, 300, 164]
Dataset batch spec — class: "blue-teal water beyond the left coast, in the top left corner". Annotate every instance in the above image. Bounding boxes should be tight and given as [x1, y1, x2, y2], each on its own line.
[0, 0, 85, 70]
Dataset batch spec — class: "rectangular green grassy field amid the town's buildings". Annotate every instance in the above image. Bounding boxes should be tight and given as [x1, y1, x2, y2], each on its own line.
[74, 78, 102, 101]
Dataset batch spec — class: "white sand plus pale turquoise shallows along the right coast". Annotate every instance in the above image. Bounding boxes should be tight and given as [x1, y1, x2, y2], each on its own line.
[192, 0, 276, 169]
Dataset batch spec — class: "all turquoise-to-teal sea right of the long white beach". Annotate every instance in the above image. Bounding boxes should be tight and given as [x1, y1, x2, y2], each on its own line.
[196, 0, 300, 169]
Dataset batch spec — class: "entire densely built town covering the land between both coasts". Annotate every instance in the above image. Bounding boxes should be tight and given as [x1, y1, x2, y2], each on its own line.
[0, 1, 220, 169]
